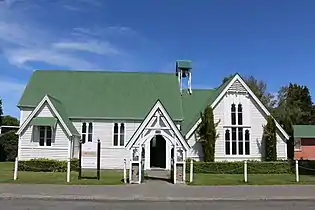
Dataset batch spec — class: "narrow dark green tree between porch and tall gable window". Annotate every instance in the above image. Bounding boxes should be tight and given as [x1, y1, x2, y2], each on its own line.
[198, 105, 219, 162]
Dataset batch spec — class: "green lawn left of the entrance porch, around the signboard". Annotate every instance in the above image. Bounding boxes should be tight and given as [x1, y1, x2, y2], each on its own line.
[0, 162, 123, 185]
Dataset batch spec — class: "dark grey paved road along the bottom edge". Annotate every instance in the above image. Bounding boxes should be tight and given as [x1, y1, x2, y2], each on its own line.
[0, 199, 315, 210]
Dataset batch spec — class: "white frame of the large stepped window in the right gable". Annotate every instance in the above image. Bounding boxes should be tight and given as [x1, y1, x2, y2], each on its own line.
[226, 102, 252, 157]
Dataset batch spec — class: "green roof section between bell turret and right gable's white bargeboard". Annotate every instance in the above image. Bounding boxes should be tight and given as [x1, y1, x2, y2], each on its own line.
[181, 75, 235, 134]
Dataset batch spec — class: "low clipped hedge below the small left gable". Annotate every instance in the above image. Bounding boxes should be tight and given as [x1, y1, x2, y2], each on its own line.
[18, 158, 79, 172]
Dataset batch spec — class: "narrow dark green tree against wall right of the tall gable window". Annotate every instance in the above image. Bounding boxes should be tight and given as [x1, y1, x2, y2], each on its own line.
[263, 116, 277, 161]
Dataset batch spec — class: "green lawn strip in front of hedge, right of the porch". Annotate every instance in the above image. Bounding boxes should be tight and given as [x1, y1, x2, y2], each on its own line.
[190, 173, 315, 185]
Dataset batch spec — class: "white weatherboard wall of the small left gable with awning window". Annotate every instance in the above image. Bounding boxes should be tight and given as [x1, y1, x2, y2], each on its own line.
[19, 103, 69, 160]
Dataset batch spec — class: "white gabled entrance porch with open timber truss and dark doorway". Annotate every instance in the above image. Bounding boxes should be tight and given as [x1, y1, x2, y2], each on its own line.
[126, 101, 189, 183]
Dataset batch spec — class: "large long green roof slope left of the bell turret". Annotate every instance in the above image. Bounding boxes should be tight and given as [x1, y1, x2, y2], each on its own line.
[18, 70, 183, 120]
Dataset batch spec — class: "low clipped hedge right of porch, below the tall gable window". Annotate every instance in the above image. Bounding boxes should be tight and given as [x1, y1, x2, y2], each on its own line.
[186, 161, 294, 174]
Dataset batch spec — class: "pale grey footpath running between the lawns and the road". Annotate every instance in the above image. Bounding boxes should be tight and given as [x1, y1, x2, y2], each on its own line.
[0, 181, 315, 201]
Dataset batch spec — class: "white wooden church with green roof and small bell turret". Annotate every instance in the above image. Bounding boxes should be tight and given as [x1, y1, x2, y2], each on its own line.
[17, 61, 288, 183]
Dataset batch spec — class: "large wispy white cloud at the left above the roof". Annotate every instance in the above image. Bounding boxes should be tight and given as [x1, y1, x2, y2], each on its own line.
[0, 10, 122, 69]
